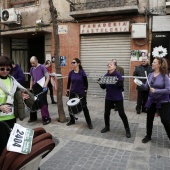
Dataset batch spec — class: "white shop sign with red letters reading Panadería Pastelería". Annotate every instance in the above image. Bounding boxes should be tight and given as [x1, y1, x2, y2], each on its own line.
[80, 21, 129, 34]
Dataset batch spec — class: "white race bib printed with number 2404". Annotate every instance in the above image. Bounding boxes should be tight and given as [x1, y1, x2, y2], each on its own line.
[7, 123, 34, 154]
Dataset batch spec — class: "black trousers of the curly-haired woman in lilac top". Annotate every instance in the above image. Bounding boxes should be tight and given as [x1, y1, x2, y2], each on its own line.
[146, 103, 170, 139]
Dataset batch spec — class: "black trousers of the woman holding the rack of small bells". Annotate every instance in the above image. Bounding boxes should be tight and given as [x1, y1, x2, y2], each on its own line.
[104, 99, 129, 129]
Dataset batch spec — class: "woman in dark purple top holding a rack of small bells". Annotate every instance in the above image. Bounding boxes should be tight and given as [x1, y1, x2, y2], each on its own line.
[100, 61, 131, 138]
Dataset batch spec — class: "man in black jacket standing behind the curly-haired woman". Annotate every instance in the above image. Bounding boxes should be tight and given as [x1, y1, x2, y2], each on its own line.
[133, 57, 152, 114]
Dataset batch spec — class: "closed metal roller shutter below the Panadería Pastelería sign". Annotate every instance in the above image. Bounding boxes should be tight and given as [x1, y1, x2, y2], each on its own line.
[81, 34, 131, 99]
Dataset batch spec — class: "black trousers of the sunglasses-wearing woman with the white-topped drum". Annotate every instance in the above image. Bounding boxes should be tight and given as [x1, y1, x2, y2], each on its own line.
[69, 93, 91, 125]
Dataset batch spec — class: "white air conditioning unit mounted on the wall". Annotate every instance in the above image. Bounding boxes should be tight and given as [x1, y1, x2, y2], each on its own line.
[1, 8, 21, 24]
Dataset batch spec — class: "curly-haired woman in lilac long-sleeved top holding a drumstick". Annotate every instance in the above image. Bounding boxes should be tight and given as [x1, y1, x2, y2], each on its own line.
[137, 57, 170, 143]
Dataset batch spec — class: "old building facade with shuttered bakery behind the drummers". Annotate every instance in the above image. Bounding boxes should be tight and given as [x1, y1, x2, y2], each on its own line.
[1, 0, 169, 100]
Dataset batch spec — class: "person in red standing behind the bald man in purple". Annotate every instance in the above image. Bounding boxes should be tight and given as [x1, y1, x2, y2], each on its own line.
[44, 60, 57, 104]
